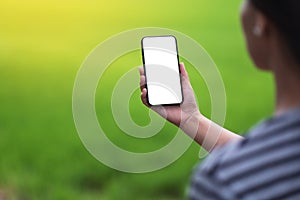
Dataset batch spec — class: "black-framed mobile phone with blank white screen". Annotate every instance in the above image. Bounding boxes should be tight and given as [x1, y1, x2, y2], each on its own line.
[142, 35, 183, 106]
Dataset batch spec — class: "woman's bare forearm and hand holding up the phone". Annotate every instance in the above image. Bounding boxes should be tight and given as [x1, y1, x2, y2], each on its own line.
[139, 64, 242, 152]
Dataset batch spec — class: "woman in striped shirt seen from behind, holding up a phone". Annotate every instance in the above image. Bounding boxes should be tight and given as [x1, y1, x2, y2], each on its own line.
[140, 0, 300, 200]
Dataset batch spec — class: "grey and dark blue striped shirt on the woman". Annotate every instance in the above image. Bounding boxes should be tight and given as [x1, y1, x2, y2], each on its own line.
[188, 109, 300, 200]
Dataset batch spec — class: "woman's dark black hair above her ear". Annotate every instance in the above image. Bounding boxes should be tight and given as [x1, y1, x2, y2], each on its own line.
[250, 0, 300, 64]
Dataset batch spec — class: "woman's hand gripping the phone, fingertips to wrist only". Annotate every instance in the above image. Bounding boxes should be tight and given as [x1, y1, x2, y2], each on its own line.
[139, 63, 201, 127]
